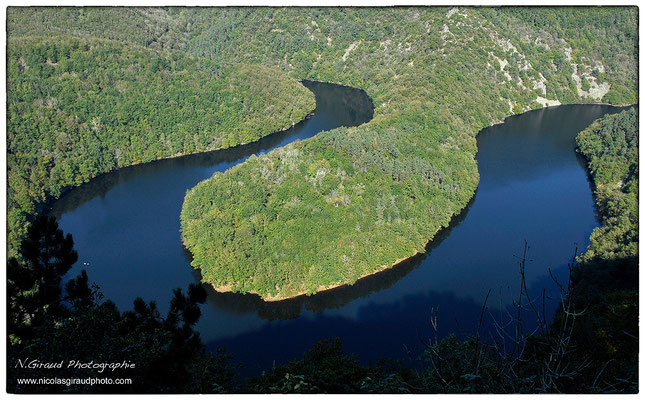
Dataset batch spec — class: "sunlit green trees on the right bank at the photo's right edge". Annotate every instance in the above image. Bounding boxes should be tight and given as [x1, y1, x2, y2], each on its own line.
[576, 108, 638, 261]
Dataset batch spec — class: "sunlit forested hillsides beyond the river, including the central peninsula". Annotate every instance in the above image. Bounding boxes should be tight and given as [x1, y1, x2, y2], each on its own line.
[7, 7, 638, 299]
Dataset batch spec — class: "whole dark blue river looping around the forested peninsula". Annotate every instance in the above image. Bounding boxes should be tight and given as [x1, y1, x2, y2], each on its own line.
[53, 83, 619, 374]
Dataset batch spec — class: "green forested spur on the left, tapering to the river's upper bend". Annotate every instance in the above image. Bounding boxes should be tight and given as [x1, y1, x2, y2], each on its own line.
[7, 31, 315, 252]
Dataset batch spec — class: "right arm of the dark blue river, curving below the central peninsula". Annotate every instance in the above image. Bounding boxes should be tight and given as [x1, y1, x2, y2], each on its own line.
[199, 105, 620, 374]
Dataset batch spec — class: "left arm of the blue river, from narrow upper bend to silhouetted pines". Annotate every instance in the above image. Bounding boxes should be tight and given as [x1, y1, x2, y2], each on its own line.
[51, 81, 373, 339]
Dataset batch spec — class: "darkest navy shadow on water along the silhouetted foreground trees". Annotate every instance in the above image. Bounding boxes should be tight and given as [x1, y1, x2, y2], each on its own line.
[206, 276, 564, 377]
